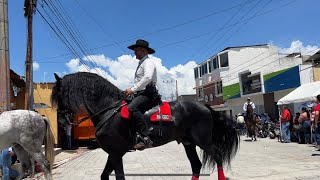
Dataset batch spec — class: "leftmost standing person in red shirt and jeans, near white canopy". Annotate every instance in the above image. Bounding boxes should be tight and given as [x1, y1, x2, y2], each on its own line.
[280, 105, 292, 143]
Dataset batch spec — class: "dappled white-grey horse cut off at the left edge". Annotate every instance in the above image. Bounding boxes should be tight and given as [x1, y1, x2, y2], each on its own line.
[0, 110, 54, 180]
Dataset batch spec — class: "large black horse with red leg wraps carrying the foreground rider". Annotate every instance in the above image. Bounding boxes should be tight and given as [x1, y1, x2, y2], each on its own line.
[51, 72, 239, 180]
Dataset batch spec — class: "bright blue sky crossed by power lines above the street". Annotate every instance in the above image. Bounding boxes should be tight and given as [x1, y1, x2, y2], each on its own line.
[9, 0, 320, 97]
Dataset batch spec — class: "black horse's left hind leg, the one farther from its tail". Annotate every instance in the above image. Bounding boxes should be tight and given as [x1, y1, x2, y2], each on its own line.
[183, 144, 202, 180]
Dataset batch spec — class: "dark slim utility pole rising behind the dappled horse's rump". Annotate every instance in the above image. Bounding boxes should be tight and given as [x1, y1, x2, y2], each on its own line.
[24, 0, 37, 110]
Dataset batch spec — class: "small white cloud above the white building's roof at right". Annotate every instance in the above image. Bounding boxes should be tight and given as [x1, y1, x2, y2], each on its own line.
[278, 40, 320, 55]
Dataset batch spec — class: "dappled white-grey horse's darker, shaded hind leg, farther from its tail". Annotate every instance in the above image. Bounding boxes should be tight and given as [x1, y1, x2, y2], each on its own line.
[13, 144, 34, 180]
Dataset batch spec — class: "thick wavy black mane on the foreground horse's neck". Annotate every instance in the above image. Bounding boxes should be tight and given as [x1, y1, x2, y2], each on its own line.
[51, 72, 121, 113]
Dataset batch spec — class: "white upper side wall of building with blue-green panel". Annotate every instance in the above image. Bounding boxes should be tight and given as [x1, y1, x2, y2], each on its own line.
[221, 45, 302, 86]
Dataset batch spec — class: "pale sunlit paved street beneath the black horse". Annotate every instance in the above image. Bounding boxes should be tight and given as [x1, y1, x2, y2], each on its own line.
[46, 137, 320, 180]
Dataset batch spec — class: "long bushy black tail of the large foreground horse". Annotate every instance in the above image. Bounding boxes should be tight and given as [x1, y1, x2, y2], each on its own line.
[202, 104, 240, 167]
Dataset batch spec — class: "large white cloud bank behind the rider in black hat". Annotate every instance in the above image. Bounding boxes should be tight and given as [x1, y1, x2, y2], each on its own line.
[66, 55, 197, 99]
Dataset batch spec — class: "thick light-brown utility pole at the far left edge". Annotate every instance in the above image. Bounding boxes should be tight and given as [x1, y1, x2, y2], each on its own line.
[0, 0, 11, 112]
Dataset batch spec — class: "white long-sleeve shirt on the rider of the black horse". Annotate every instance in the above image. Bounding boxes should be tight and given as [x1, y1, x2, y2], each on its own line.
[131, 55, 157, 92]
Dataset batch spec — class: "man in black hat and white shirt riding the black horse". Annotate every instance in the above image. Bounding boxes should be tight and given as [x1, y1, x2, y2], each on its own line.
[125, 39, 158, 149]
